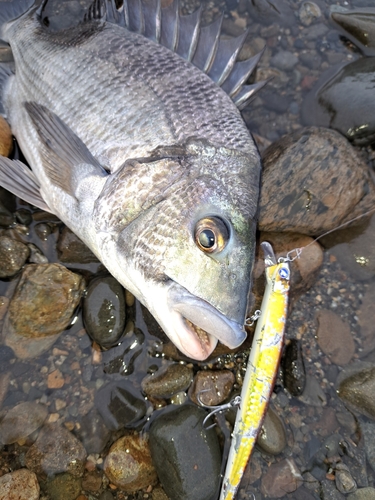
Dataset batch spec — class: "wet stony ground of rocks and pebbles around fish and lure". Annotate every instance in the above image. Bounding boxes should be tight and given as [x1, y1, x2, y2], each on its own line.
[0, 0, 375, 500]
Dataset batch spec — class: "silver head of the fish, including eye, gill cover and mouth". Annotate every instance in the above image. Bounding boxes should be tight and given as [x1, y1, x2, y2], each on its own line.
[114, 144, 260, 360]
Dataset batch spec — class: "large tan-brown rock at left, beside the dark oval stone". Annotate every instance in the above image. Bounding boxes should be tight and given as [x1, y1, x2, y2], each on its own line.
[3, 264, 84, 359]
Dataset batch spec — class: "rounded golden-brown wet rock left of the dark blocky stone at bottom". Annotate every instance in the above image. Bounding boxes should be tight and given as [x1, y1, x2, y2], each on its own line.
[104, 435, 157, 493]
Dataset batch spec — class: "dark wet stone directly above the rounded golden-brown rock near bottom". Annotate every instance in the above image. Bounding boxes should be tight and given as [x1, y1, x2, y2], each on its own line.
[95, 380, 147, 431]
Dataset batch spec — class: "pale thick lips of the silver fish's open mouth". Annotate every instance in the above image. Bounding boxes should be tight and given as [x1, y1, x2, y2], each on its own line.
[167, 280, 246, 359]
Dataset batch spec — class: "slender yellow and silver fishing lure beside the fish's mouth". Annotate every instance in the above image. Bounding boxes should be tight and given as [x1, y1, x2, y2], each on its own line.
[220, 242, 291, 500]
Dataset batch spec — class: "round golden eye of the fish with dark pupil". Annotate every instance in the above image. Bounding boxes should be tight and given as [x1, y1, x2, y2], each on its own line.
[194, 217, 229, 253]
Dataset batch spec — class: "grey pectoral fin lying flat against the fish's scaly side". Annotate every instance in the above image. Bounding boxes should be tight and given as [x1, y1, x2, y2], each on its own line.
[25, 102, 108, 199]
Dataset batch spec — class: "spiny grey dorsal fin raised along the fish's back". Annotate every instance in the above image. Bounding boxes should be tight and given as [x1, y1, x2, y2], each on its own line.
[93, 0, 266, 109]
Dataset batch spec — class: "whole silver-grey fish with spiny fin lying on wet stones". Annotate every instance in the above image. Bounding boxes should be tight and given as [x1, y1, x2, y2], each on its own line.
[0, 0, 264, 360]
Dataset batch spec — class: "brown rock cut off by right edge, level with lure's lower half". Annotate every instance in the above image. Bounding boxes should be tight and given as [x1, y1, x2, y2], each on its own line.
[338, 368, 375, 419]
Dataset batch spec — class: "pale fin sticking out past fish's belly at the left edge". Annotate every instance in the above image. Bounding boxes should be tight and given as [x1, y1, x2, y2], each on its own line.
[0, 156, 53, 213]
